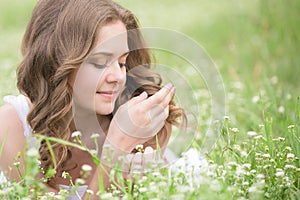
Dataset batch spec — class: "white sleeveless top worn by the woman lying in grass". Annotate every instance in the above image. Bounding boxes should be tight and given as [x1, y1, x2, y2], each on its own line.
[4, 94, 88, 200]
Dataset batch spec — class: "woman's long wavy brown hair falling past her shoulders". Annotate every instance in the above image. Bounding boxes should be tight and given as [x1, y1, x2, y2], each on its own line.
[17, 0, 183, 184]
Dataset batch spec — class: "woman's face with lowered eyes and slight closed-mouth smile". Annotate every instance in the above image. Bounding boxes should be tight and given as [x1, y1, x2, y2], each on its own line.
[69, 20, 129, 115]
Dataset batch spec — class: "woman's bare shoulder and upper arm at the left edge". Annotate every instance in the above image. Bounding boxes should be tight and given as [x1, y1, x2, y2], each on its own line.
[0, 104, 26, 178]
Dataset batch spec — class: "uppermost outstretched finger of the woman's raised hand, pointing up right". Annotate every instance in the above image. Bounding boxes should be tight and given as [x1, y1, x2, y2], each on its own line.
[142, 83, 175, 110]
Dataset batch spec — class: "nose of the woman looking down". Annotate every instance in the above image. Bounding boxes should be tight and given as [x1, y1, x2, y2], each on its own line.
[106, 60, 126, 83]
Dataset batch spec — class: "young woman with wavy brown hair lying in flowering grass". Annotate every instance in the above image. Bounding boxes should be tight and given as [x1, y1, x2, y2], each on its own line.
[0, 0, 183, 198]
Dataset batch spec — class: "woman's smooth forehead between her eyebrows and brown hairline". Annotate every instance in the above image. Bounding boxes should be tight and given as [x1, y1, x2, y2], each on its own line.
[92, 20, 129, 56]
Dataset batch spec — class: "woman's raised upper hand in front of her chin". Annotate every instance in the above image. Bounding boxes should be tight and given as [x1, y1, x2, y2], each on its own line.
[107, 83, 175, 153]
